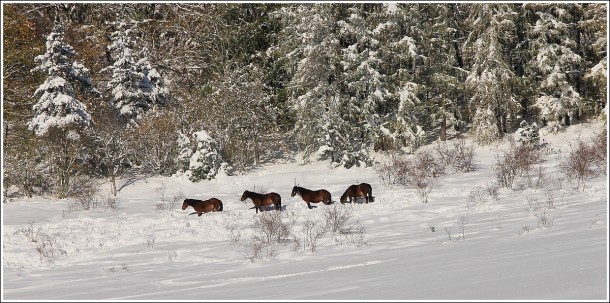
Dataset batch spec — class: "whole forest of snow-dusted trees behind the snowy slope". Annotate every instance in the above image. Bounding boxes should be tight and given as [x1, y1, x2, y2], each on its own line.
[2, 2, 608, 198]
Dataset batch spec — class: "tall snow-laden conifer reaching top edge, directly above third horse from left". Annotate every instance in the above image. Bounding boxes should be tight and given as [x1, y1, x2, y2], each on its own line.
[276, 4, 348, 166]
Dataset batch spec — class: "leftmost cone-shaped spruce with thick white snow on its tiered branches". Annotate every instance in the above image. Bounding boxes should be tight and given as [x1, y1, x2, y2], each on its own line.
[28, 21, 97, 136]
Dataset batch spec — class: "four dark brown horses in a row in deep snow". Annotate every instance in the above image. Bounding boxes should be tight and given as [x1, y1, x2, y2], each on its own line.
[182, 183, 374, 216]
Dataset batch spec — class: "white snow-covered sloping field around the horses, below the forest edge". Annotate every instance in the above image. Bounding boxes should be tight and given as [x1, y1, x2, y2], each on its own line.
[2, 124, 608, 301]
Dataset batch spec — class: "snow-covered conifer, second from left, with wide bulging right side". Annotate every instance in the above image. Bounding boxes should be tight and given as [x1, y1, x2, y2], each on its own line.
[102, 21, 169, 125]
